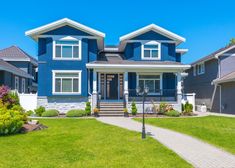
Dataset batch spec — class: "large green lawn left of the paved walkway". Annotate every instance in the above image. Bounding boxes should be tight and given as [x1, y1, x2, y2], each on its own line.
[0, 119, 191, 168]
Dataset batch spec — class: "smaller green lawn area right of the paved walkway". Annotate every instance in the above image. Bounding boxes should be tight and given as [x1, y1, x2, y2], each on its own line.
[135, 116, 235, 154]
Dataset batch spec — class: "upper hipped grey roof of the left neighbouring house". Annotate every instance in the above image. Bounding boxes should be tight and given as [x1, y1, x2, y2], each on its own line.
[0, 46, 38, 66]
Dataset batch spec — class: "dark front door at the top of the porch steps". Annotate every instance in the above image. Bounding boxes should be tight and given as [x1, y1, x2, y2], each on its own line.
[106, 74, 118, 100]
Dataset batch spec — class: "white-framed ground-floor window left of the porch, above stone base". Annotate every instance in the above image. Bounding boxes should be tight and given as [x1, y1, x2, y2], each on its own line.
[52, 70, 82, 94]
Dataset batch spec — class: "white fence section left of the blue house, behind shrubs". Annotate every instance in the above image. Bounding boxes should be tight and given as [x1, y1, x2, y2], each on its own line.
[19, 93, 38, 111]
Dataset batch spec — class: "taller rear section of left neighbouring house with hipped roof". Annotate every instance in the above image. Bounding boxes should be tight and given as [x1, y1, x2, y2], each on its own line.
[0, 46, 38, 93]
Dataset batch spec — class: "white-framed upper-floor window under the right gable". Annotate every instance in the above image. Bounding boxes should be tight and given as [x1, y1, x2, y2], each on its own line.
[141, 41, 161, 60]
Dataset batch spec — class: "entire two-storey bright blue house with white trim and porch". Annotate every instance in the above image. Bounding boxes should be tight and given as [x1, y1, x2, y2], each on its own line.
[26, 18, 190, 113]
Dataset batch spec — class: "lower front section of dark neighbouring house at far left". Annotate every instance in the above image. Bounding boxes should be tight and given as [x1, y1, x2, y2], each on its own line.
[0, 59, 32, 93]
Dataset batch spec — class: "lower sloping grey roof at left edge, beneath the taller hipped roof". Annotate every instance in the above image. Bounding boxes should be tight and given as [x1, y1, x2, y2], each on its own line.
[0, 59, 32, 78]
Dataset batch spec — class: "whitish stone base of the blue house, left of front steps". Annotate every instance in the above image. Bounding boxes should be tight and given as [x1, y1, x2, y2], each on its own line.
[37, 97, 88, 113]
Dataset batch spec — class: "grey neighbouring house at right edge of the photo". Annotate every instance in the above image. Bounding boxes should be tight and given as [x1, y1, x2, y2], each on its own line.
[184, 45, 235, 114]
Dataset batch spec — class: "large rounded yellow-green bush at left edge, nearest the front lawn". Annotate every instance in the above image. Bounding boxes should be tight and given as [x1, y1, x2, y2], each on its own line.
[0, 110, 25, 135]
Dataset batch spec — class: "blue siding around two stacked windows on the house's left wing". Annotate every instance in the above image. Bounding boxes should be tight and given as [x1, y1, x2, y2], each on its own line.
[38, 38, 98, 96]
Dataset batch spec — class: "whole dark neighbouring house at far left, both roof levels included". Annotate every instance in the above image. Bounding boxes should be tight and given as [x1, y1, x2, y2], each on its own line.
[0, 46, 38, 93]
